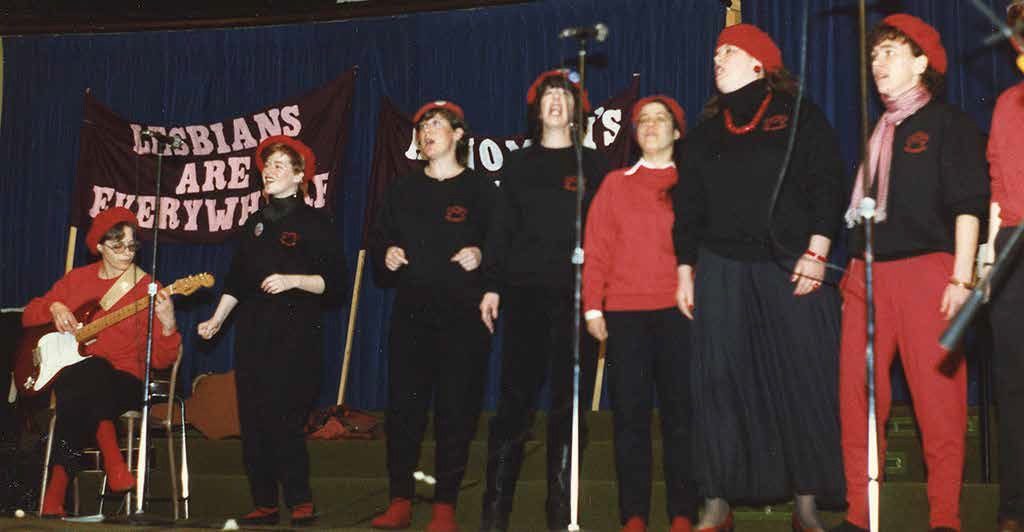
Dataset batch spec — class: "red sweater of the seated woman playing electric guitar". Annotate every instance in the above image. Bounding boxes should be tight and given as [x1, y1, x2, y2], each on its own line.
[22, 261, 181, 379]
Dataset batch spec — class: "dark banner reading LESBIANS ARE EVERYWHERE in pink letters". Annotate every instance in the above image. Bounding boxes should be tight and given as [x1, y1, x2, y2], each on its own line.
[71, 68, 356, 242]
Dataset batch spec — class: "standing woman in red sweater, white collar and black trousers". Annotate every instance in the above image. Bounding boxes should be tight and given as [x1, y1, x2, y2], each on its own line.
[583, 94, 696, 532]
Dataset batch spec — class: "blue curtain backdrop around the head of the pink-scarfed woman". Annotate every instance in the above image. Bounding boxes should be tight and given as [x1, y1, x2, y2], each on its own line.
[742, 0, 1022, 404]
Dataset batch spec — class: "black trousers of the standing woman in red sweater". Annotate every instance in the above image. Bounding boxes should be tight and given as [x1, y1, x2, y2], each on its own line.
[605, 308, 696, 524]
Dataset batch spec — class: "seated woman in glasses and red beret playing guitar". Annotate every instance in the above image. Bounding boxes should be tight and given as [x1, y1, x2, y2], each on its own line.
[22, 207, 181, 517]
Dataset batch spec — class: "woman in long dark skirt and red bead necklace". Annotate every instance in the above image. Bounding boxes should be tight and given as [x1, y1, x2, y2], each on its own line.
[674, 25, 843, 531]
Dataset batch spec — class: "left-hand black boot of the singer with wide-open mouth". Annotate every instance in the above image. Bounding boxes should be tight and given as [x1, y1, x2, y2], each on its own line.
[480, 434, 523, 532]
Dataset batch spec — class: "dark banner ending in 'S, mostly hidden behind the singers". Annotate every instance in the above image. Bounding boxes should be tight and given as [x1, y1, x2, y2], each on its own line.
[362, 75, 640, 241]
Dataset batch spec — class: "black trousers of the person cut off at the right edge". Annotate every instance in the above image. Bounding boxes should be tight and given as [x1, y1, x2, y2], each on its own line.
[990, 227, 1024, 520]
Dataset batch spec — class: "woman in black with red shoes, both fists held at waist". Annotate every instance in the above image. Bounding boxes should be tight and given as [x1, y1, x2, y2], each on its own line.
[370, 100, 495, 532]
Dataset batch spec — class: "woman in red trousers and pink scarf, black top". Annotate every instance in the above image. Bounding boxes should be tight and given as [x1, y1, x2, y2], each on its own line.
[837, 14, 989, 531]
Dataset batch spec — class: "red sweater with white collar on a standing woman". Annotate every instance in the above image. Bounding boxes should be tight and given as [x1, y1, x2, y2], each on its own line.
[583, 161, 679, 311]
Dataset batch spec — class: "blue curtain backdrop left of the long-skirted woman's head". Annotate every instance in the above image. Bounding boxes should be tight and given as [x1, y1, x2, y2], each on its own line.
[0, 0, 724, 409]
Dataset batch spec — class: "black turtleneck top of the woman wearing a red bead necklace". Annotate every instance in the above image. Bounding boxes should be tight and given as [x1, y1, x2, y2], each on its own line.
[673, 80, 843, 265]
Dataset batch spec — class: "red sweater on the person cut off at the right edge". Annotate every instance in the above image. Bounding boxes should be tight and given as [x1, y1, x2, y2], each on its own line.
[988, 82, 1024, 227]
